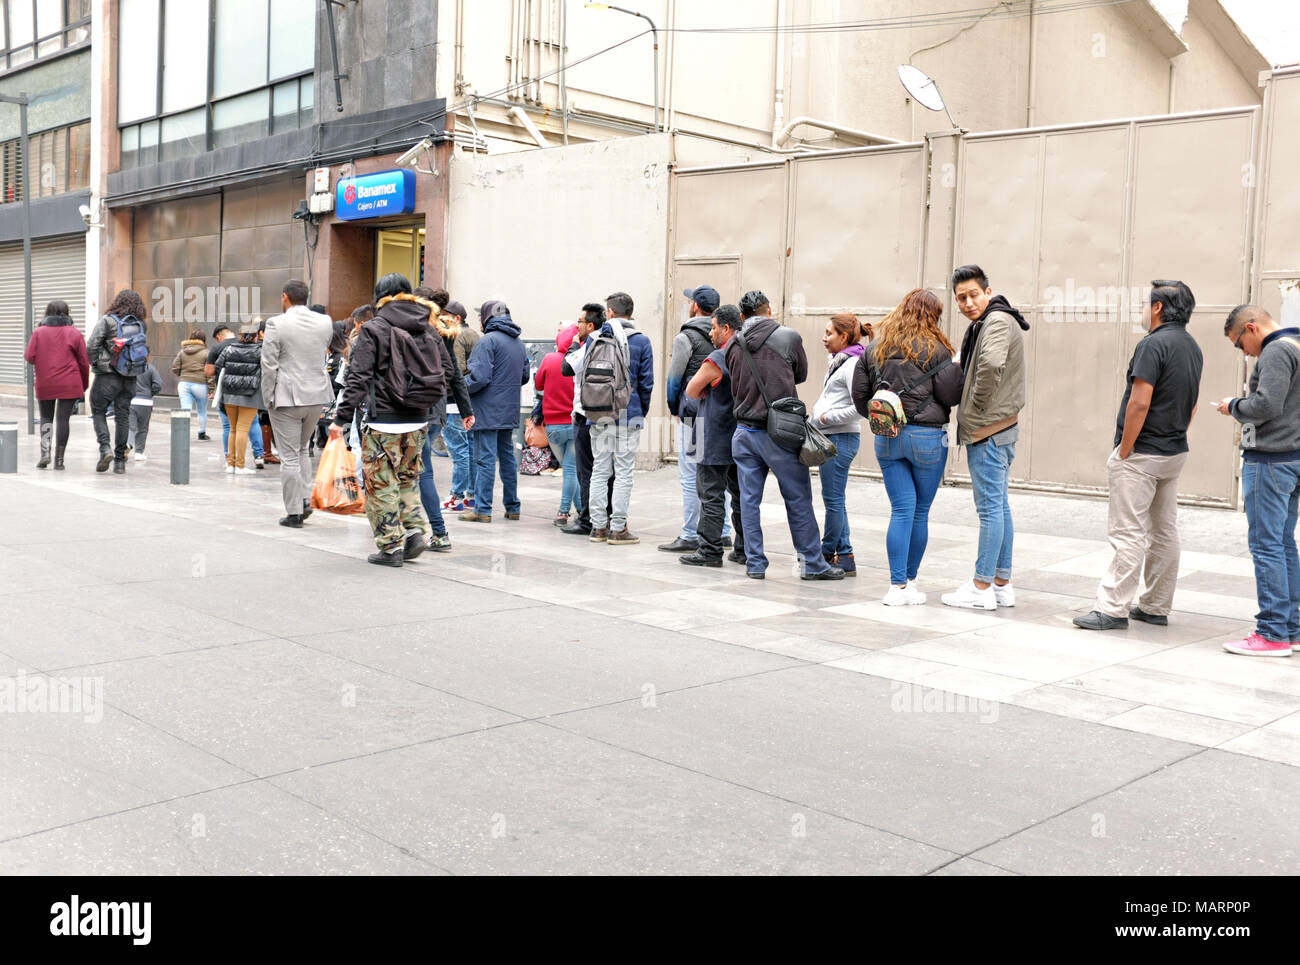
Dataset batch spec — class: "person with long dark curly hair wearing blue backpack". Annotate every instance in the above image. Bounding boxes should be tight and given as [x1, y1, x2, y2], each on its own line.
[86, 289, 148, 475]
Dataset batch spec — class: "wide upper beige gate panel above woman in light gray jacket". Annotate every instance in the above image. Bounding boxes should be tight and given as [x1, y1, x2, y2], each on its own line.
[789, 147, 924, 308]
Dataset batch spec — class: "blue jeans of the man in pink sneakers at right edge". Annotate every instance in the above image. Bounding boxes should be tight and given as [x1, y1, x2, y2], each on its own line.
[1242, 462, 1300, 644]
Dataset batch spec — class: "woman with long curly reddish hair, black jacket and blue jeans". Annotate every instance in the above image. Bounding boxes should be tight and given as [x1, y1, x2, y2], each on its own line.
[852, 289, 962, 606]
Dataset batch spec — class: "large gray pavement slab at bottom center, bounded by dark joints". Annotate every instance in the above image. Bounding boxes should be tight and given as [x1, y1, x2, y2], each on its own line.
[272, 723, 954, 874]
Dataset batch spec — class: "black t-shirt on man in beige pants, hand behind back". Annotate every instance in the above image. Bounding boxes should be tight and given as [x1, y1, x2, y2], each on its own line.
[1115, 324, 1203, 455]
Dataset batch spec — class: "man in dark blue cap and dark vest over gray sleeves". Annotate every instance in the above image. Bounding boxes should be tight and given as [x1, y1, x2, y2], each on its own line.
[659, 285, 731, 553]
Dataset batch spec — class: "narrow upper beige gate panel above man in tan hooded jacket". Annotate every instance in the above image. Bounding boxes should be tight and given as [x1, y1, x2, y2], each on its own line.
[956, 135, 1040, 305]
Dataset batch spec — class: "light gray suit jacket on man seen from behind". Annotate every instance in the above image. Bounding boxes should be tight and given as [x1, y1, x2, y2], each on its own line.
[261, 304, 334, 408]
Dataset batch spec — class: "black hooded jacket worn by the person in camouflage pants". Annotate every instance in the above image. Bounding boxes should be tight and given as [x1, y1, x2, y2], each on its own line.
[334, 295, 473, 425]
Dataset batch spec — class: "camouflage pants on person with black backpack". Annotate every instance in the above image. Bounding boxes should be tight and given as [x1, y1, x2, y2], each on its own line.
[361, 427, 429, 553]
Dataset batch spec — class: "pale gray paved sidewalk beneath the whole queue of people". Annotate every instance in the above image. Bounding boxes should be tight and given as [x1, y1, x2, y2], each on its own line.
[0, 411, 1300, 874]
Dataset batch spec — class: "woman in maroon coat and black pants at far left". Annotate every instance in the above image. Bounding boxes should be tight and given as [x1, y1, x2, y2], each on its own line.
[23, 299, 90, 469]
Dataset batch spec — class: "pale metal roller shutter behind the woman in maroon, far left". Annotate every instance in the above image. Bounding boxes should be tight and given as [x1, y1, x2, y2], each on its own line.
[0, 234, 86, 385]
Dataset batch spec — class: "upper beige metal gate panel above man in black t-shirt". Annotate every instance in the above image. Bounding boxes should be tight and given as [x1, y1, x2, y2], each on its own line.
[1131, 114, 1252, 307]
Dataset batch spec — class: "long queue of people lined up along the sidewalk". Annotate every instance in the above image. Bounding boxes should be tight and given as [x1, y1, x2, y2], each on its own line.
[26, 265, 1300, 657]
